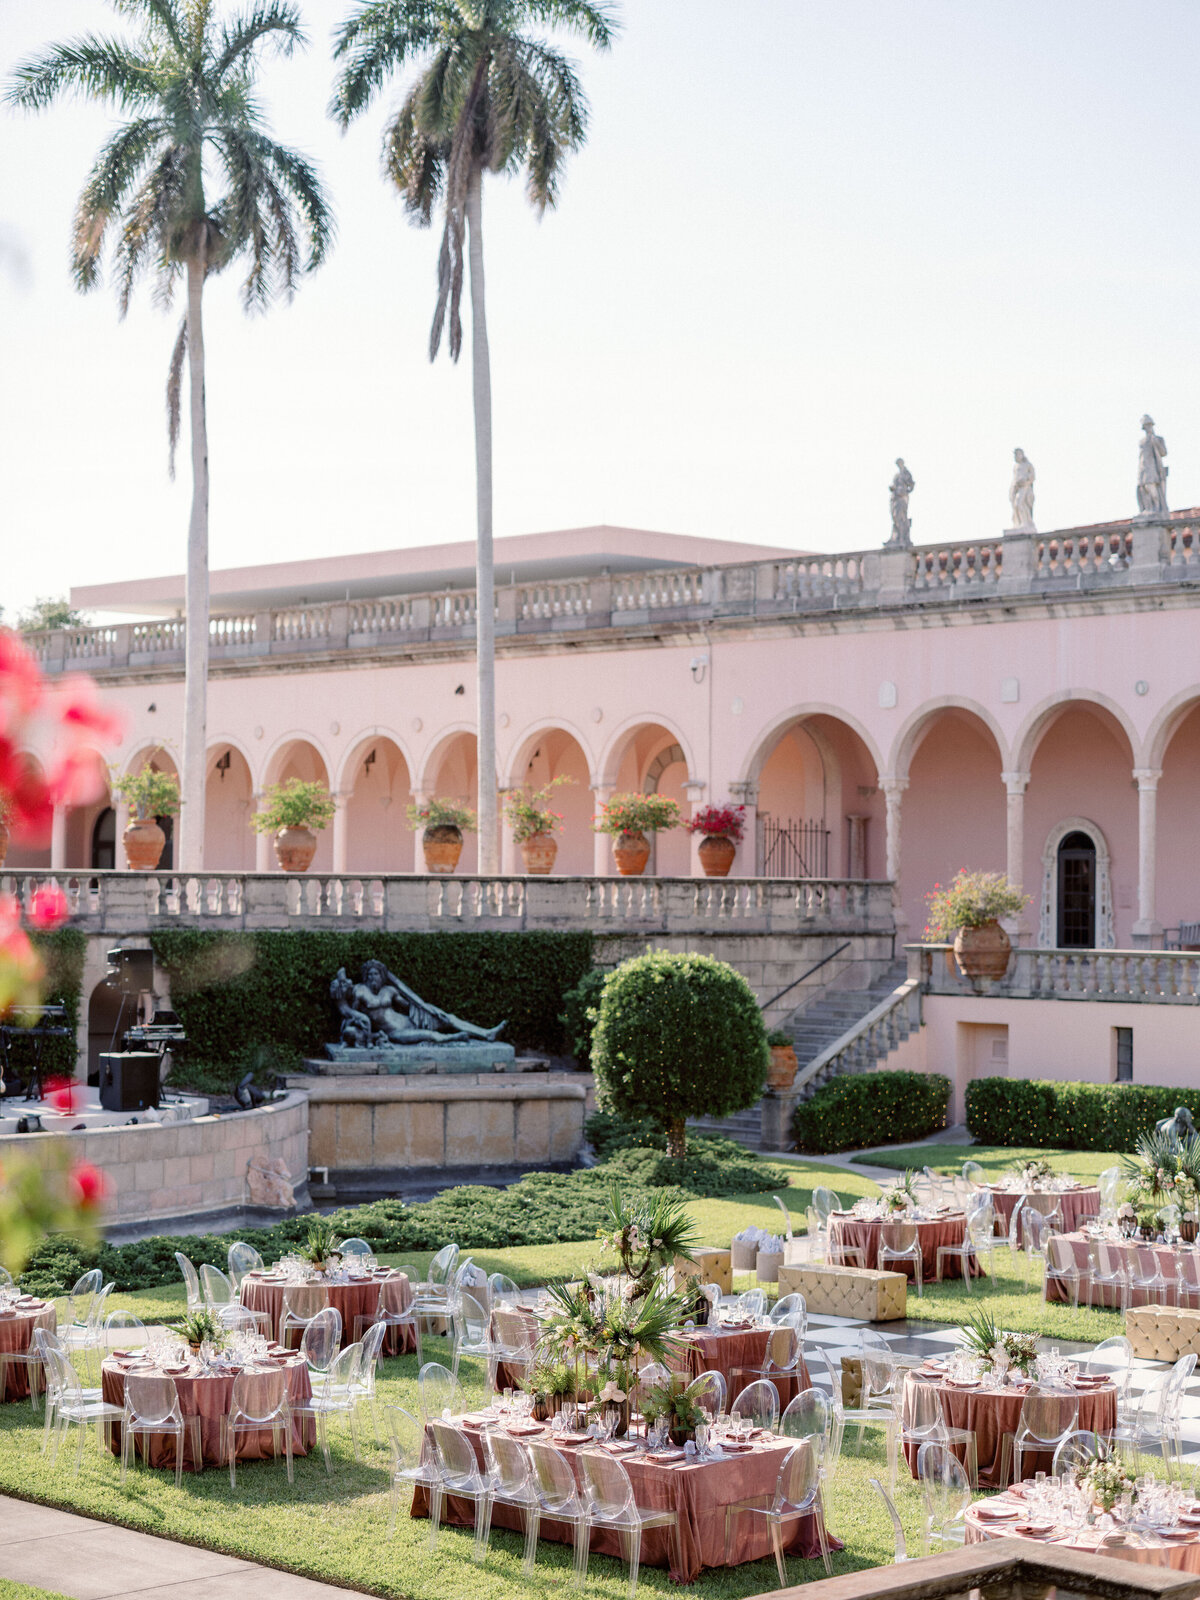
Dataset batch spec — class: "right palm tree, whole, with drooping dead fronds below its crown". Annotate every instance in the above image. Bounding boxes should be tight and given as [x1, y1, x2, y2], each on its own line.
[330, 0, 616, 872]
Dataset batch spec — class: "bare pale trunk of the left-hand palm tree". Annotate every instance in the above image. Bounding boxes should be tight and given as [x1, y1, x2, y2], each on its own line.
[176, 246, 208, 872]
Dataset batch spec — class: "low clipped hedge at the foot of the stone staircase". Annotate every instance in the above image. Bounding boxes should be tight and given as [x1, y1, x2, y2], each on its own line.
[792, 1072, 950, 1155]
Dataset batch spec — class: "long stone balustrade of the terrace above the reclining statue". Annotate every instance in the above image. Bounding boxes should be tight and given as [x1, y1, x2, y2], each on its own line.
[0, 870, 893, 936]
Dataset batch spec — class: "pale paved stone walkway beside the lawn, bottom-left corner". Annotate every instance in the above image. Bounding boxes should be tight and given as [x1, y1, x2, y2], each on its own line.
[0, 1494, 356, 1600]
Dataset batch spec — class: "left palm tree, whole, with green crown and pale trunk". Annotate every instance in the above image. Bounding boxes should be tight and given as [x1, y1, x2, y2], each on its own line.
[5, 0, 333, 872]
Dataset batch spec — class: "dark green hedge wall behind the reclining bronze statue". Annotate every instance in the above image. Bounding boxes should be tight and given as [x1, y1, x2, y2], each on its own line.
[150, 928, 594, 1070]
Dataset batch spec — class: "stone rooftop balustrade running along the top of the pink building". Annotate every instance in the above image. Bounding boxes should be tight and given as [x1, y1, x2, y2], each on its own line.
[27, 517, 1200, 674]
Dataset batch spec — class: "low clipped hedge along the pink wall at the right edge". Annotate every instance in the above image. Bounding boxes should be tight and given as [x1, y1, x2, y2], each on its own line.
[966, 1078, 1194, 1150]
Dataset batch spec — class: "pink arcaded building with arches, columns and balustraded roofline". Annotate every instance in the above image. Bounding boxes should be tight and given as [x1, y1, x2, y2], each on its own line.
[16, 514, 1200, 949]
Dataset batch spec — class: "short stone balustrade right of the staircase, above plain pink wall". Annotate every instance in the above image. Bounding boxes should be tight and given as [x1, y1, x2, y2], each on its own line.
[906, 944, 1200, 1005]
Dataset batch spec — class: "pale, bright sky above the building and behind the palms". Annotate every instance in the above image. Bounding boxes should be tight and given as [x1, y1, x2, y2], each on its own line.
[0, 0, 1200, 618]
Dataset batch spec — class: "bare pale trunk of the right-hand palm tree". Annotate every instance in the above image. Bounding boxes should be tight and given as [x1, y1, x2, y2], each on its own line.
[467, 166, 499, 874]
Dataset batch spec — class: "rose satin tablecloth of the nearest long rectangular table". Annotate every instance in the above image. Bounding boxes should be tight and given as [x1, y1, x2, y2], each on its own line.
[411, 1418, 842, 1584]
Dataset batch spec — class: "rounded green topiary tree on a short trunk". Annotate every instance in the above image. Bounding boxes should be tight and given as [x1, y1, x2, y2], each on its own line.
[592, 950, 770, 1157]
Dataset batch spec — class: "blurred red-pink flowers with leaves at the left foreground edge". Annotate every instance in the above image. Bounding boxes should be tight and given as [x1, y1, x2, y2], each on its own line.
[0, 629, 120, 1274]
